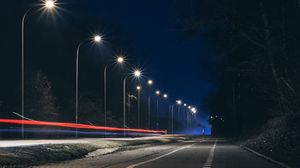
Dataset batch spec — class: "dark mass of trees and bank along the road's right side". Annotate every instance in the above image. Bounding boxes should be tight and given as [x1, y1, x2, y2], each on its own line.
[178, 0, 300, 167]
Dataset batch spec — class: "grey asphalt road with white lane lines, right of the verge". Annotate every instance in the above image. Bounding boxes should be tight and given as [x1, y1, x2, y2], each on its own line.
[37, 139, 280, 168]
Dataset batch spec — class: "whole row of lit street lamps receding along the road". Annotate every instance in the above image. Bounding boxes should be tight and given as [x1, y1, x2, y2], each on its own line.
[21, 0, 197, 138]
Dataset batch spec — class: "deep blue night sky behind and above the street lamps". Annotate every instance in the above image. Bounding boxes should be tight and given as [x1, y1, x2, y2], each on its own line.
[0, 0, 216, 131]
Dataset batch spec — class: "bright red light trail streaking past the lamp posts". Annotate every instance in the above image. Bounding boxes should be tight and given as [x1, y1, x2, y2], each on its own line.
[0, 119, 167, 134]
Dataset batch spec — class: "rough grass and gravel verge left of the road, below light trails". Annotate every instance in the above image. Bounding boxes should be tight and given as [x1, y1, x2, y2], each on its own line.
[0, 136, 193, 168]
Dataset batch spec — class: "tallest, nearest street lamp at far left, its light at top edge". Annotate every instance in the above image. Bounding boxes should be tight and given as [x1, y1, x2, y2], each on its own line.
[21, 0, 55, 138]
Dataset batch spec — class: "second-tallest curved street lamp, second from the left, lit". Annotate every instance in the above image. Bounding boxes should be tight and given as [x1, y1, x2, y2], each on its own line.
[75, 35, 101, 137]
